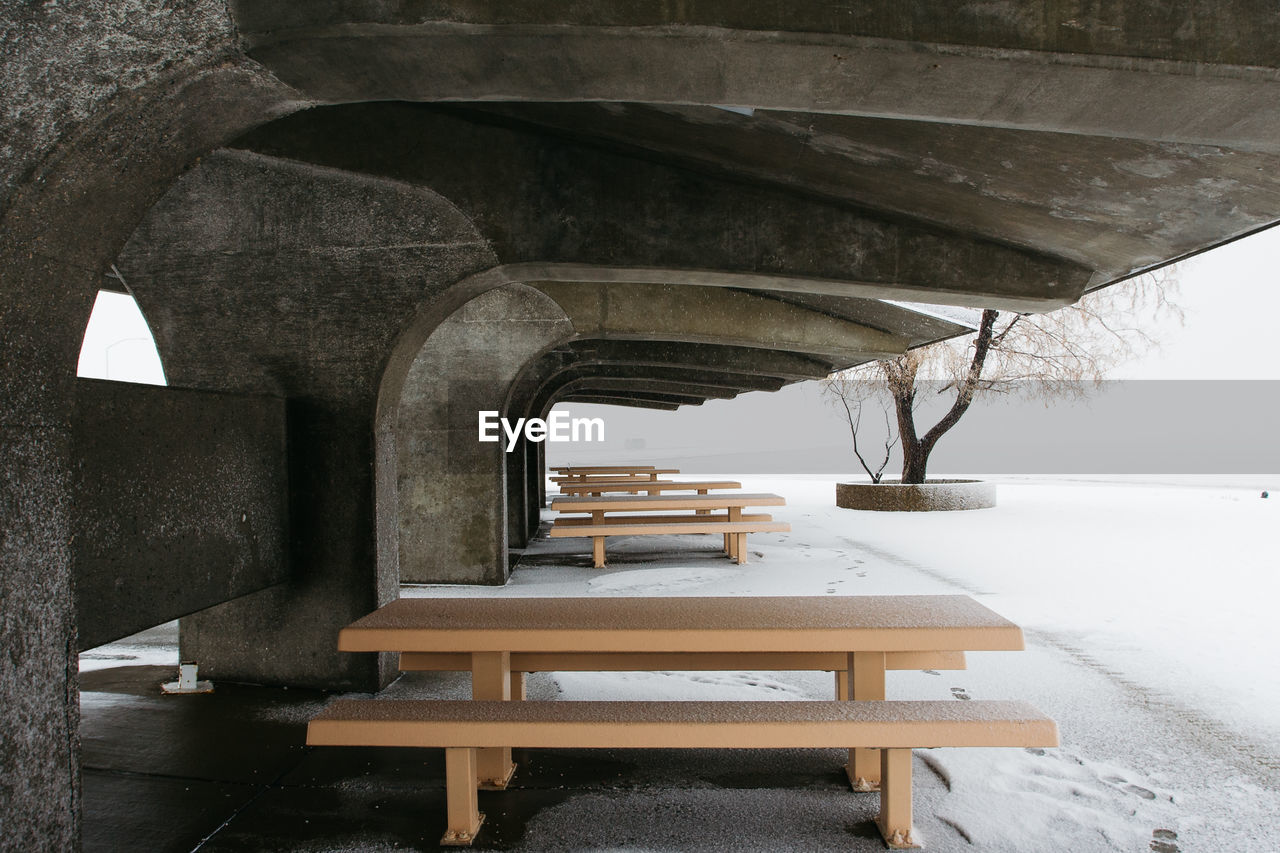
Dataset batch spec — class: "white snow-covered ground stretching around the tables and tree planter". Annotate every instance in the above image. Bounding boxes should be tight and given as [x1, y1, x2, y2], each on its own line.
[404, 475, 1280, 853]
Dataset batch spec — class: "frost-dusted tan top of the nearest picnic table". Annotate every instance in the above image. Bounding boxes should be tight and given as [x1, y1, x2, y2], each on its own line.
[338, 596, 1023, 653]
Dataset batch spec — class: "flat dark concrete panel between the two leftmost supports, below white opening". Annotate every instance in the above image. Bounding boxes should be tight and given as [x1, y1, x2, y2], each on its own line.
[72, 379, 288, 649]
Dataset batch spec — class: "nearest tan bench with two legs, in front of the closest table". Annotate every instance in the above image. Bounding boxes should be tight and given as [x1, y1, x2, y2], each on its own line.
[307, 699, 1057, 848]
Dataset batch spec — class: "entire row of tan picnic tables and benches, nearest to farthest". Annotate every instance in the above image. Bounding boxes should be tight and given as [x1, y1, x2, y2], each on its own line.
[307, 469, 1057, 848]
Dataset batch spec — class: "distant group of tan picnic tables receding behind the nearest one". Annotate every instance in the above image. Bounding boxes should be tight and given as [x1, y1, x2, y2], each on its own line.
[549, 465, 791, 569]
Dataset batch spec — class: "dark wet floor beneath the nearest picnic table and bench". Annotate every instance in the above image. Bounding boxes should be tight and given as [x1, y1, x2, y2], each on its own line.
[81, 653, 906, 853]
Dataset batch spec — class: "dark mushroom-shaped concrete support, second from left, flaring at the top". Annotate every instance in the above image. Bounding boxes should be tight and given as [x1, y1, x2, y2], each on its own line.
[118, 152, 493, 689]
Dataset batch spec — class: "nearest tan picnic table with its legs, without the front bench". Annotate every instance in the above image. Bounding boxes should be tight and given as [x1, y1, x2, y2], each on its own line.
[338, 596, 1023, 790]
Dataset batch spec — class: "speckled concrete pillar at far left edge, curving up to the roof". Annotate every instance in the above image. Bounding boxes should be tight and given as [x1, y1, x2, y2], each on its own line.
[0, 0, 297, 852]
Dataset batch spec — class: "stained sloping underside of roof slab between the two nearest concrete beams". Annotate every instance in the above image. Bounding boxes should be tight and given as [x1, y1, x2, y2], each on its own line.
[467, 104, 1280, 277]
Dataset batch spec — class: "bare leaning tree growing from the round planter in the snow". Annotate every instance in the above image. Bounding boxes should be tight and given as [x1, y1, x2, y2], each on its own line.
[823, 268, 1181, 483]
